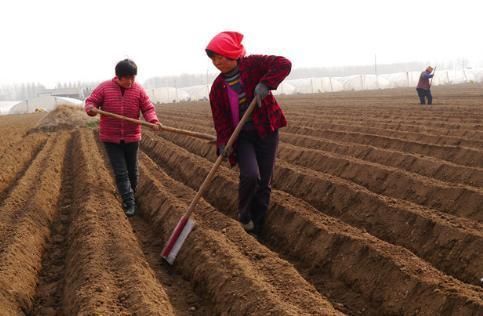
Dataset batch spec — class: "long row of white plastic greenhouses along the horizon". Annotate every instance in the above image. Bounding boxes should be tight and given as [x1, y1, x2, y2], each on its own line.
[4, 68, 483, 115]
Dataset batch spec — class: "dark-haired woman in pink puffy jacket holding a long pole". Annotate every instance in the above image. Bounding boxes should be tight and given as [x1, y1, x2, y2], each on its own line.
[85, 59, 159, 216]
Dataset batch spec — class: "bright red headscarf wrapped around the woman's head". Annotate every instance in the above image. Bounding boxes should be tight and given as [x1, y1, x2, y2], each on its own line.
[206, 32, 245, 59]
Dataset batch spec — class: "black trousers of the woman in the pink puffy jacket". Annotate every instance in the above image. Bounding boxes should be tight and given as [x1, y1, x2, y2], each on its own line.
[104, 142, 139, 208]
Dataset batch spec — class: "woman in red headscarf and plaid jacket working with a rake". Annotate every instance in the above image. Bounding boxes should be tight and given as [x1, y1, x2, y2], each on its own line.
[206, 32, 292, 235]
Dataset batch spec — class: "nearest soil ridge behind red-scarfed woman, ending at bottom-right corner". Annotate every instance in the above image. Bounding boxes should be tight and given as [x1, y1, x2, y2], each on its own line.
[143, 135, 483, 313]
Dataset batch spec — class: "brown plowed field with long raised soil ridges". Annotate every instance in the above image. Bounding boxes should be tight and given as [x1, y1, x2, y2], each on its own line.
[0, 86, 483, 315]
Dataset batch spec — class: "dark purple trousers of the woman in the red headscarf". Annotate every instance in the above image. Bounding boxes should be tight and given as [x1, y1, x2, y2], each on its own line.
[237, 130, 278, 226]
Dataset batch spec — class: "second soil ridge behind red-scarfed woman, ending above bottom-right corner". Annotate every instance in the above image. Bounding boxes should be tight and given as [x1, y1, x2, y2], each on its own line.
[152, 128, 483, 284]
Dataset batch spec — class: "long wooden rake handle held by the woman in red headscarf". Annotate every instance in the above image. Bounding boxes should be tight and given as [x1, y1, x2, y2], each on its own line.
[183, 98, 257, 218]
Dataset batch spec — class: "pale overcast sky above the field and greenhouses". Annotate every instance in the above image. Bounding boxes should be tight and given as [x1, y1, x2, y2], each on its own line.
[0, 0, 483, 85]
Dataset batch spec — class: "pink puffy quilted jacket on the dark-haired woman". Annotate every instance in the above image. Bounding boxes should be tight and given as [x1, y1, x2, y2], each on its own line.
[85, 78, 159, 143]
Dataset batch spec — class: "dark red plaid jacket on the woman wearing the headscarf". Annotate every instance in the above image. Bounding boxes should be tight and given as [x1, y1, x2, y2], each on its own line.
[210, 55, 292, 165]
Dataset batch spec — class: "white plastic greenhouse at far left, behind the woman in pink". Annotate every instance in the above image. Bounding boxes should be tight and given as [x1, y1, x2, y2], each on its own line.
[8, 95, 83, 114]
